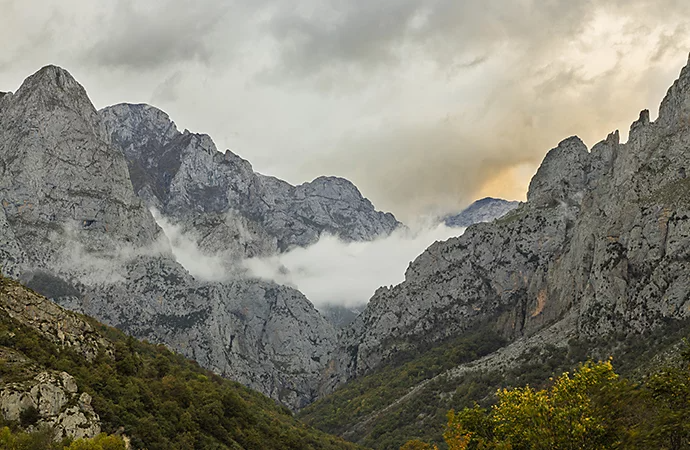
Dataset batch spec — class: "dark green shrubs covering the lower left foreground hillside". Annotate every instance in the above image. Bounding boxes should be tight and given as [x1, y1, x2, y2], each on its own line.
[0, 279, 356, 450]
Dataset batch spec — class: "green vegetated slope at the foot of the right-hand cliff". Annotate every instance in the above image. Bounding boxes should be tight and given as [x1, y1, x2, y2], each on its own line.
[298, 321, 688, 450]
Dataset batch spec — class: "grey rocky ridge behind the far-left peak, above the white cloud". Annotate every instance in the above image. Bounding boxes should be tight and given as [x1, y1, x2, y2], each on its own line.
[99, 104, 400, 259]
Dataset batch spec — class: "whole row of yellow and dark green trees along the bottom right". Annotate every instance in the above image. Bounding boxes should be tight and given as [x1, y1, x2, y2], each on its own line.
[402, 350, 690, 450]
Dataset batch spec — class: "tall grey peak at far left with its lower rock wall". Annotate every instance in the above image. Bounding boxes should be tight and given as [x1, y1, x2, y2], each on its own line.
[0, 66, 335, 408]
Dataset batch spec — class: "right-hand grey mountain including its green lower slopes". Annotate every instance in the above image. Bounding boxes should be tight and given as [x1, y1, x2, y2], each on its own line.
[292, 57, 690, 449]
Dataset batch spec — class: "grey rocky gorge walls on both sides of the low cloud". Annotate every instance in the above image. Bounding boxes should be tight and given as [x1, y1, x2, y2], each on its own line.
[0, 54, 690, 448]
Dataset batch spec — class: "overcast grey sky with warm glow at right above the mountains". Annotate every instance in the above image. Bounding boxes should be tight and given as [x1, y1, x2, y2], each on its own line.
[0, 0, 690, 220]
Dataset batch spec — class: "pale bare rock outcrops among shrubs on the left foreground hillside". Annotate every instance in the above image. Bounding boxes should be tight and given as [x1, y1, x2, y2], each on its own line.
[0, 279, 103, 438]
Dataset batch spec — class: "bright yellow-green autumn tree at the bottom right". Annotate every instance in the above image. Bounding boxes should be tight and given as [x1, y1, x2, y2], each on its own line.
[406, 361, 631, 450]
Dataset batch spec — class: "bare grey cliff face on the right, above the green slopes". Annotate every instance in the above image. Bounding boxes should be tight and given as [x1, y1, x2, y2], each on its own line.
[329, 59, 690, 389]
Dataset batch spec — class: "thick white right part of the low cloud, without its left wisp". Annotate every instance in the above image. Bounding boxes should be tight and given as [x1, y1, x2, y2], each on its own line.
[244, 225, 465, 308]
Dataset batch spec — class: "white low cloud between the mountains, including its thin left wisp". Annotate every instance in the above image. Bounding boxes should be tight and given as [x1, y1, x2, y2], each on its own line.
[151, 209, 465, 308]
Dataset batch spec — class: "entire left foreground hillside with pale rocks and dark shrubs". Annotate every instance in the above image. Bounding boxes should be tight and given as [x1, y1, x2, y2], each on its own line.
[0, 277, 356, 450]
